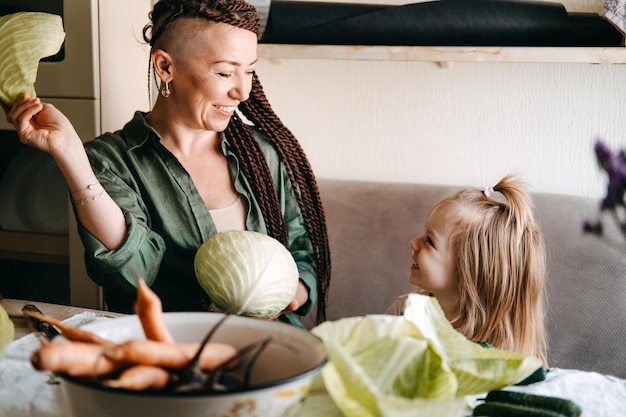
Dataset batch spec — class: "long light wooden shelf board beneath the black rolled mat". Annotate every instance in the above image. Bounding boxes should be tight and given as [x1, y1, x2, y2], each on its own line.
[258, 43, 626, 64]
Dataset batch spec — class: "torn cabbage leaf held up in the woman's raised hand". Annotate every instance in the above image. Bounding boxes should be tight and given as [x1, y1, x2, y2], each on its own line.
[0, 12, 65, 106]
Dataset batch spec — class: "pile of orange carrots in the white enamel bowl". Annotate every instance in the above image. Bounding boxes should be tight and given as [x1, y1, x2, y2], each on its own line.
[24, 279, 238, 390]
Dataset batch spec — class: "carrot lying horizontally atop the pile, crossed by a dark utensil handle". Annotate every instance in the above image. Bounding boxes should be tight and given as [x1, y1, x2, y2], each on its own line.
[104, 340, 237, 370]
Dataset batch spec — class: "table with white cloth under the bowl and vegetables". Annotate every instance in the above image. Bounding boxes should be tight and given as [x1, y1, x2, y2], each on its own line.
[0, 299, 626, 417]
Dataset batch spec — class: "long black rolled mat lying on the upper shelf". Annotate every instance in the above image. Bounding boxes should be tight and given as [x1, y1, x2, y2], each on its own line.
[261, 0, 623, 46]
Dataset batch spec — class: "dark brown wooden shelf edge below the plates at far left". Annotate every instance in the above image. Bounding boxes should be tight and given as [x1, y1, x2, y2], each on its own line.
[0, 231, 69, 264]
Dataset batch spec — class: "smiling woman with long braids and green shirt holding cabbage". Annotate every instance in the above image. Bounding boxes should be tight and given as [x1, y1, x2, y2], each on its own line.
[7, 0, 330, 325]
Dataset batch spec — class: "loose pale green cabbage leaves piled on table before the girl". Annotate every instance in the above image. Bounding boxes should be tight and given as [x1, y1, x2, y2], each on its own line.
[311, 294, 542, 417]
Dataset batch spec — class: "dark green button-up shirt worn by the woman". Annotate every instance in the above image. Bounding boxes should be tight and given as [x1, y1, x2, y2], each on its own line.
[78, 112, 317, 325]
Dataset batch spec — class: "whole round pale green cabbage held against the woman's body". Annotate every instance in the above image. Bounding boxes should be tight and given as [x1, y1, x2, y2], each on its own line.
[194, 230, 299, 319]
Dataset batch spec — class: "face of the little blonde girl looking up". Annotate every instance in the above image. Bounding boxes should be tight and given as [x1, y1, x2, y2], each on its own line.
[409, 205, 458, 300]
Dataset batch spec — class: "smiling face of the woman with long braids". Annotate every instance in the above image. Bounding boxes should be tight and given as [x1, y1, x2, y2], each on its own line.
[167, 19, 257, 132]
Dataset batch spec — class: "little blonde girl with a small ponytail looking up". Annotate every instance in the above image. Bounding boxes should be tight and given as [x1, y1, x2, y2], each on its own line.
[387, 175, 547, 365]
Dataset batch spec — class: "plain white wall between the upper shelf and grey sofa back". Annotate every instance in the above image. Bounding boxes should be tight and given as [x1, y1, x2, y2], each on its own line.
[252, 0, 626, 197]
